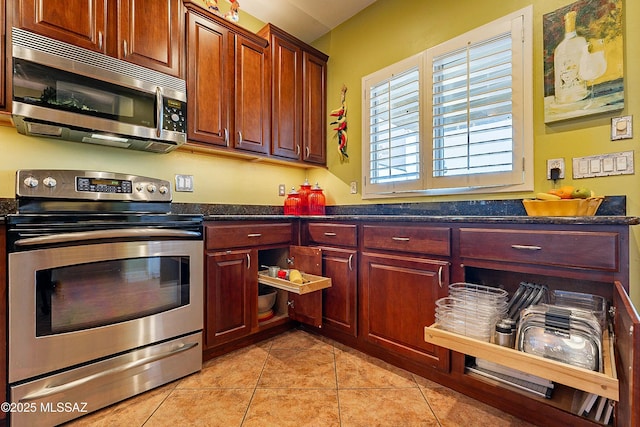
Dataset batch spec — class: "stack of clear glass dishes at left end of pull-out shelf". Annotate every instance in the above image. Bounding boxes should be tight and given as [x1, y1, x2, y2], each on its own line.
[436, 283, 508, 342]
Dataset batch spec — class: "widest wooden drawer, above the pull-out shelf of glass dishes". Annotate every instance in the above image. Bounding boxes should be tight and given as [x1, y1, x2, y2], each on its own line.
[460, 228, 619, 271]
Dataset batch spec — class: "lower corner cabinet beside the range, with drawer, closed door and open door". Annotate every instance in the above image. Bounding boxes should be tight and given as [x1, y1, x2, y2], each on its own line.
[204, 222, 322, 358]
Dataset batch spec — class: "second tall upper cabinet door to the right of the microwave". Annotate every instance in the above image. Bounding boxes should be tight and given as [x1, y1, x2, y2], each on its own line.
[234, 35, 271, 154]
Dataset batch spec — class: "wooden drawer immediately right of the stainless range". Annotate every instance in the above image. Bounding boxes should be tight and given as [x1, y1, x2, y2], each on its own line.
[205, 223, 291, 249]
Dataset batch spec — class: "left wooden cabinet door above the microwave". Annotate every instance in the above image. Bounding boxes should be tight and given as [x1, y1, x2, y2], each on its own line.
[13, 0, 107, 52]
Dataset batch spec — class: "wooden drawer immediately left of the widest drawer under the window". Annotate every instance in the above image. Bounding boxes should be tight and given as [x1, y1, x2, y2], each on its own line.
[363, 225, 451, 256]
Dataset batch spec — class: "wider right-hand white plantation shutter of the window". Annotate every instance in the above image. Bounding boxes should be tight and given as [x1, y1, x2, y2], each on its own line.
[427, 13, 524, 188]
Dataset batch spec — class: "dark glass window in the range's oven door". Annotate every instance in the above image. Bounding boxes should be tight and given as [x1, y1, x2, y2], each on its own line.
[35, 256, 190, 336]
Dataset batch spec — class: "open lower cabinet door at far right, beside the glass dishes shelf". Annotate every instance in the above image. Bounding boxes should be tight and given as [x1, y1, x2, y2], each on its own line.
[613, 282, 640, 426]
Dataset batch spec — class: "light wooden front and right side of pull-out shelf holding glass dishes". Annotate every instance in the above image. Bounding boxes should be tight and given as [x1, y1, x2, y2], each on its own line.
[424, 323, 619, 401]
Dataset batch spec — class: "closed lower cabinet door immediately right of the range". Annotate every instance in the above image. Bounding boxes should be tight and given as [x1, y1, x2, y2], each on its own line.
[204, 250, 258, 347]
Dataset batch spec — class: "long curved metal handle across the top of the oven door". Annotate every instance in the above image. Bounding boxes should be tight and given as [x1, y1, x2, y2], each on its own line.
[15, 228, 202, 246]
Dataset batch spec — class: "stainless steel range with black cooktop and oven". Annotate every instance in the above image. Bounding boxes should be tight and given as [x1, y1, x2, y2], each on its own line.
[7, 170, 203, 426]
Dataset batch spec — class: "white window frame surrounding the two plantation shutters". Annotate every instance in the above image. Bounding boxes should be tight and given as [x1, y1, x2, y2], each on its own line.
[362, 6, 534, 199]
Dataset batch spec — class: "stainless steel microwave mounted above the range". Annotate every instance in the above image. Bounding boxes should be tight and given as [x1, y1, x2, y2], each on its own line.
[12, 28, 187, 153]
